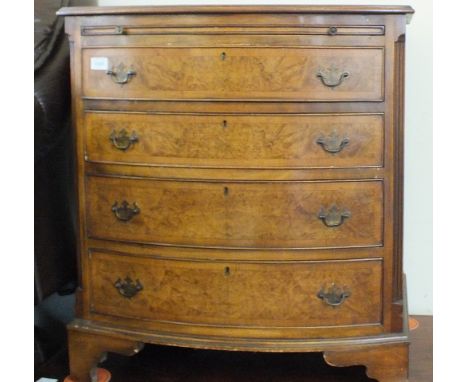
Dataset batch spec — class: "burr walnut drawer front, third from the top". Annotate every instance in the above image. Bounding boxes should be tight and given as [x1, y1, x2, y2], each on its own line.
[87, 177, 383, 248]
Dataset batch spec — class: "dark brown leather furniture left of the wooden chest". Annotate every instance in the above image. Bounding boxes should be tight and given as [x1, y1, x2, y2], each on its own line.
[34, 0, 95, 366]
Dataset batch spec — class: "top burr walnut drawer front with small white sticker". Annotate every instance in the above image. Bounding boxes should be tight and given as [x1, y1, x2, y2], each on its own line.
[83, 47, 384, 101]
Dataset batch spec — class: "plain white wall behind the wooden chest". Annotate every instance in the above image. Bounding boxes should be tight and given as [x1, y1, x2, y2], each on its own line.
[99, 0, 432, 314]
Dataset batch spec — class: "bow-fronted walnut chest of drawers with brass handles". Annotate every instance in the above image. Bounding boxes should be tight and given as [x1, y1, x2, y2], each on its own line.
[59, 6, 413, 382]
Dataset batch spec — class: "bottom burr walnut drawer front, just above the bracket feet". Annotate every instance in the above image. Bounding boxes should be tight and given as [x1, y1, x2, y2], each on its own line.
[90, 251, 382, 327]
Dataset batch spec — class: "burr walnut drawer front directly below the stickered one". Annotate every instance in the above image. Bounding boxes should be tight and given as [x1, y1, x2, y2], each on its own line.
[85, 113, 384, 168]
